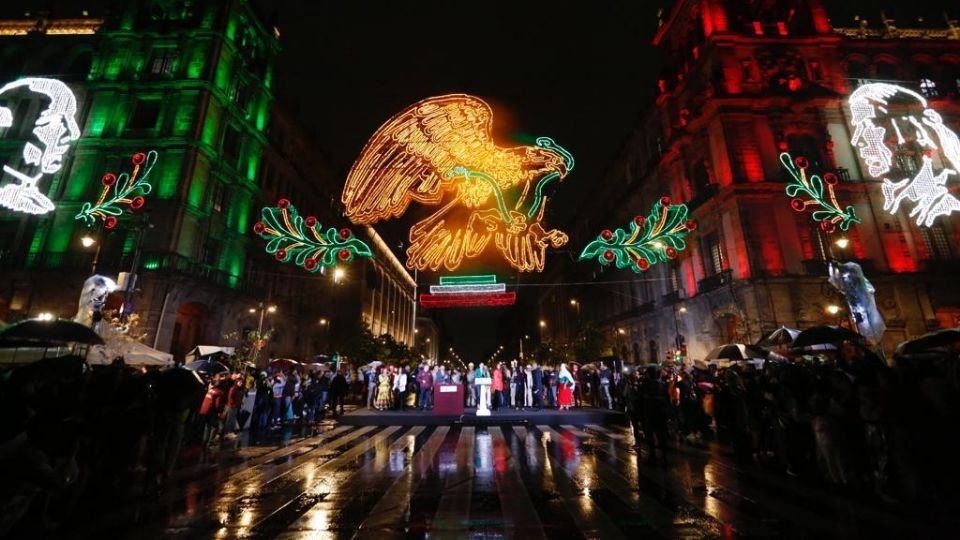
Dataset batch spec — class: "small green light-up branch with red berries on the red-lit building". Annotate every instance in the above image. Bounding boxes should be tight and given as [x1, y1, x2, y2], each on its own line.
[780, 152, 860, 233]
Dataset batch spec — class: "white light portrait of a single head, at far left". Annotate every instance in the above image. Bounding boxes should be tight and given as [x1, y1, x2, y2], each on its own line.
[0, 77, 80, 214]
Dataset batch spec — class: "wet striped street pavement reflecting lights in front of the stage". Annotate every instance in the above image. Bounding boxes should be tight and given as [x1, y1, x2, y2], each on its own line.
[65, 416, 943, 540]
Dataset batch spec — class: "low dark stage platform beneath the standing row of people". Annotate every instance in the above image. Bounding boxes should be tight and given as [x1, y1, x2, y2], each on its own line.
[338, 407, 627, 426]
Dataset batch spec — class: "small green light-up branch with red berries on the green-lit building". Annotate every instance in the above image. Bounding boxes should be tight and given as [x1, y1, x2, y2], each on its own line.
[74, 150, 157, 229]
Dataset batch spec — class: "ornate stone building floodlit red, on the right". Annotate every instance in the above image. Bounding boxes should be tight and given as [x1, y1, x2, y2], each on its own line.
[540, 0, 960, 361]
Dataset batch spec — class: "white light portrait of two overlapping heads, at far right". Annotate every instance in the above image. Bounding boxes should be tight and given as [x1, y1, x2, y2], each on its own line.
[848, 83, 960, 227]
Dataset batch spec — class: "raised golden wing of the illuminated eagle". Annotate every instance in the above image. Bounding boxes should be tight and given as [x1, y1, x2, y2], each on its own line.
[342, 94, 497, 223]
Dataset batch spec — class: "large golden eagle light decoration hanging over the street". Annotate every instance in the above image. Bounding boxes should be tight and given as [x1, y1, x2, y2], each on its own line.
[343, 94, 574, 272]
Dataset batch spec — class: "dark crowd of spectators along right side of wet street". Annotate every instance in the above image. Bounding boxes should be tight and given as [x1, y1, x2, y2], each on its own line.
[616, 342, 960, 503]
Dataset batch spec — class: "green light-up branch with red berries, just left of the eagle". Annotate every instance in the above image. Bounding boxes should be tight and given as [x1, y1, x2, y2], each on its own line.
[253, 199, 373, 272]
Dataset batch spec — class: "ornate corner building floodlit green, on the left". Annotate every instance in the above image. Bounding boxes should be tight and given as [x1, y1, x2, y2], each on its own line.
[0, 0, 292, 360]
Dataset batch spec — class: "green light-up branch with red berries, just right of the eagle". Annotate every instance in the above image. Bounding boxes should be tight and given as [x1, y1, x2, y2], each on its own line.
[580, 197, 697, 273]
